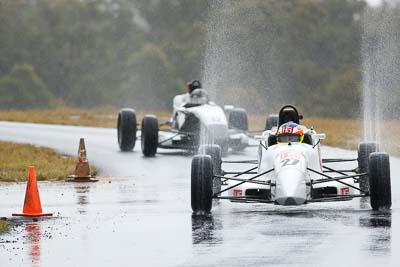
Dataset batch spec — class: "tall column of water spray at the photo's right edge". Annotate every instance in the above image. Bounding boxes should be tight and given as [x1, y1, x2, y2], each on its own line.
[361, 5, 400, 149]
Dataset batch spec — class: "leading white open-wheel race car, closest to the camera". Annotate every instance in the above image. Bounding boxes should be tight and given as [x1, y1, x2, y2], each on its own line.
[191, 105, 391, 213]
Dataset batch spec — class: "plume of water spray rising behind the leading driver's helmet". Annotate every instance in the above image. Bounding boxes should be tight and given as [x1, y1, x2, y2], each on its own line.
[202, 0, 287, 114]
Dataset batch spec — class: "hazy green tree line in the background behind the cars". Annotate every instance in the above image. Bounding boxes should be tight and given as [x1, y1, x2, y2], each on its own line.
[0, 0, 398, 117]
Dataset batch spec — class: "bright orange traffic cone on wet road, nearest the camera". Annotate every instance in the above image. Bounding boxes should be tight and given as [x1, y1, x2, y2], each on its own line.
[12, 166, 53, 217]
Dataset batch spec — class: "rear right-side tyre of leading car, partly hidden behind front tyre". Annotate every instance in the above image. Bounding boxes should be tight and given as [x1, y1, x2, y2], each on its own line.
[358, 142, 379, 192]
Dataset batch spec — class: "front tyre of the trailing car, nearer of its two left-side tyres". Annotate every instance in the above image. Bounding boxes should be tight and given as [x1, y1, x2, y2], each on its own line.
[141, 115, 158, 157]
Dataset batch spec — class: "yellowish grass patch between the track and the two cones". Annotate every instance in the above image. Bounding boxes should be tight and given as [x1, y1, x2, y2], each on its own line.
[0, 142, 88, 182]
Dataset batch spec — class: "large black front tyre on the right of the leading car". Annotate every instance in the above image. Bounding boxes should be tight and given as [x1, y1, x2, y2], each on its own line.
[369, 152, 392, 210]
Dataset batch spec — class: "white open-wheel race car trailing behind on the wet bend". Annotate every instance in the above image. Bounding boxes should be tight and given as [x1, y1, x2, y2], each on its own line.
[117, 89, 249, 156]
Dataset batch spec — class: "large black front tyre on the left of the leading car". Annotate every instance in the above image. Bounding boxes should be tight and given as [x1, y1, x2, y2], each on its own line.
[191, 155, 213, 213]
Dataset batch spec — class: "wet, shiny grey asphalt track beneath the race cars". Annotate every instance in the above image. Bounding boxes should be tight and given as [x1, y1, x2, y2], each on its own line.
[0, 122, 400, 266]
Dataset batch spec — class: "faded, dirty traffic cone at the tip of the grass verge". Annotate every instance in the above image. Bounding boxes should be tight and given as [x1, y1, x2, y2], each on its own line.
[67, 138, 98, 182]
